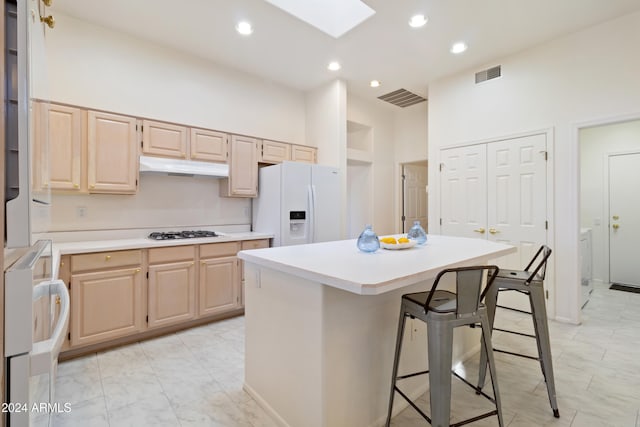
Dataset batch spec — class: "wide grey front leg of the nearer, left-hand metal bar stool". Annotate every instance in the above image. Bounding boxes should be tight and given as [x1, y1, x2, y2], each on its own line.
[427, 319, 453, 427]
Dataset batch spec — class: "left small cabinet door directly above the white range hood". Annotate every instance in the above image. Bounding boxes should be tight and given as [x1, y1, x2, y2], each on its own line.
[142, 120, 188, 159]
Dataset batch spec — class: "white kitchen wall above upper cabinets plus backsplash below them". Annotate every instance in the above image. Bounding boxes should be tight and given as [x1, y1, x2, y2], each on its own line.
[33, 14, 306, 231]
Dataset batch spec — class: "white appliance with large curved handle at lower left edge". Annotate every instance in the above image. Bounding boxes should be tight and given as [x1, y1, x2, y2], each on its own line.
[3, 240, 71, 427]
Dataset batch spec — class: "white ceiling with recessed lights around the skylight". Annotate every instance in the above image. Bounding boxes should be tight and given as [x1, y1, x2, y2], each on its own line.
[51, 0, 640, 103]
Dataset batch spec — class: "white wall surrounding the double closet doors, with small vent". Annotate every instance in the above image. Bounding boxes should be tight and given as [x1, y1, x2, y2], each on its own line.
[429, 13, 640, 322]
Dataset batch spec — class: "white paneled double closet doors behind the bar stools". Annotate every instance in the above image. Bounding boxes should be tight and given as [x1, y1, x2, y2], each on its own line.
[440, 134, 548, 308]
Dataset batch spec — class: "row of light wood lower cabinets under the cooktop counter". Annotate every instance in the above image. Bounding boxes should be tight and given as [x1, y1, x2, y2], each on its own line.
[64, 239, 269, 351]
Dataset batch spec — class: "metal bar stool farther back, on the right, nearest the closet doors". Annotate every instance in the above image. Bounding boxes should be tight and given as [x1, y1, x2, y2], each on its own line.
[478, 245, 560, 418]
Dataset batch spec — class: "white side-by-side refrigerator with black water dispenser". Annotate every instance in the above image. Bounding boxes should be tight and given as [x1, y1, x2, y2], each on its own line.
[253, 162, 341, 246]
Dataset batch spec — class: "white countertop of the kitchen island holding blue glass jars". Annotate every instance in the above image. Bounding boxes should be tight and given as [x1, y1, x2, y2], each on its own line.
[238, 235, 516, 295]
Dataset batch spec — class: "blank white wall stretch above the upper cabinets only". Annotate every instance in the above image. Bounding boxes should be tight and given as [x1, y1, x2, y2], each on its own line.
[39, 14, 305, 144]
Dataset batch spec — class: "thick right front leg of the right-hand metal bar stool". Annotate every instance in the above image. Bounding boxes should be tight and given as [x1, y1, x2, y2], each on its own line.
[529, 286, 560, 418]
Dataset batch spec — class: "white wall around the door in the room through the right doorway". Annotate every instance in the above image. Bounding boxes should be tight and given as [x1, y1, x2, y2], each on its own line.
[579, 120, 640, 281]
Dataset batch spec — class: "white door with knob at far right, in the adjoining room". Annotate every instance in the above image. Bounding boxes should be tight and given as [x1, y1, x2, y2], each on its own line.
[609, 153, 640, 286]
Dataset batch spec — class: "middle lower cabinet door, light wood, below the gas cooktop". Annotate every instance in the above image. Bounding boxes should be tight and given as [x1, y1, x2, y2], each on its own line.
[147, 261, 196, 328]
